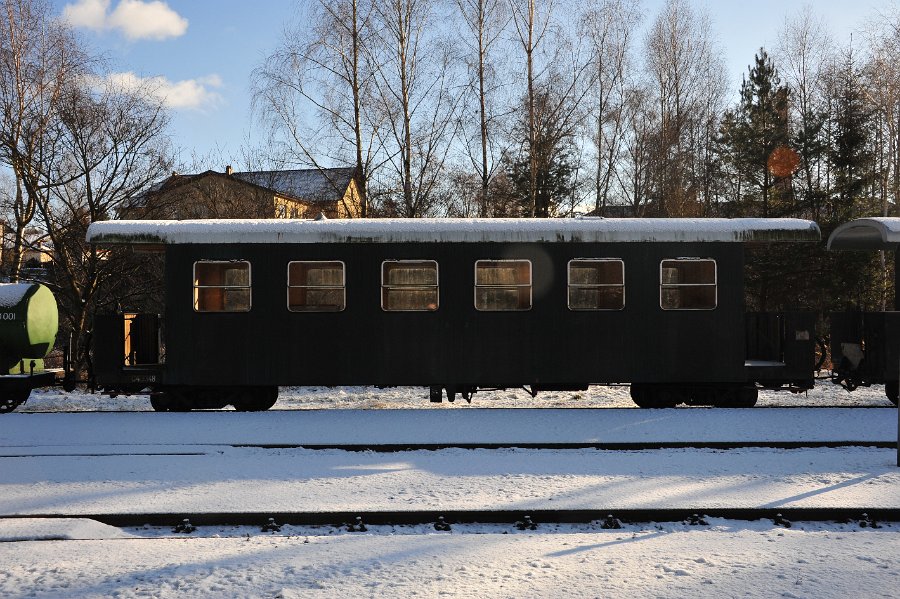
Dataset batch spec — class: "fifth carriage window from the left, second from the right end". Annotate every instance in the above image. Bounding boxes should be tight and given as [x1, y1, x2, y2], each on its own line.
[569, 258, 625, 310]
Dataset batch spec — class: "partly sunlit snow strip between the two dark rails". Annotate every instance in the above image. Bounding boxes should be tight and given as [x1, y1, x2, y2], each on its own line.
[0, 445, 900, 522]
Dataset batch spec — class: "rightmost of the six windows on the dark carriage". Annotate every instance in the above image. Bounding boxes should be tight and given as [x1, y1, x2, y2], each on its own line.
[659, 258, 717, 310]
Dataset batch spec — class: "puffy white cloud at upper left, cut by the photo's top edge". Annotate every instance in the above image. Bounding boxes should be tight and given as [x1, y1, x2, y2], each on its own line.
[63, 0, 188, 40]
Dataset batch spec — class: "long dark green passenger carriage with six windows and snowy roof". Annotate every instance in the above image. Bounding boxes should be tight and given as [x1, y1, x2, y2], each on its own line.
[87, 218, 820, 410]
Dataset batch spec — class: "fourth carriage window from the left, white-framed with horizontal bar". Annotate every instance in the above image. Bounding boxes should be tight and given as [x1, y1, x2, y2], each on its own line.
[475, 260, 531, 312]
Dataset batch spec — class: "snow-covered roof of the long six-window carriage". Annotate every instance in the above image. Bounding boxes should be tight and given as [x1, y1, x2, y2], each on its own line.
[87, 218, 821, 245]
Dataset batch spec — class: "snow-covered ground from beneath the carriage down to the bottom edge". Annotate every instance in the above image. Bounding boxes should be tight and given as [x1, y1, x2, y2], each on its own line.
[0, 385, 900, 599]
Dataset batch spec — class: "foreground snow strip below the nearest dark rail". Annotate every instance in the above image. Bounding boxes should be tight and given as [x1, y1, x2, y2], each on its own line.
[0, 520, 900, 599]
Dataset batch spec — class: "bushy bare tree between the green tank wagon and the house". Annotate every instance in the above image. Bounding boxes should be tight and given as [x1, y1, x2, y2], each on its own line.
[38, 79, 171, 371]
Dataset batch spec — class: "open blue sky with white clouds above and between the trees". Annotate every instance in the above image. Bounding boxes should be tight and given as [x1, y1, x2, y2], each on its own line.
[52, 0, 893, 170]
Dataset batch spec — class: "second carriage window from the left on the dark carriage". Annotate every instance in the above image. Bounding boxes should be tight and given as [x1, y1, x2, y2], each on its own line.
[288, 262, 347, 312]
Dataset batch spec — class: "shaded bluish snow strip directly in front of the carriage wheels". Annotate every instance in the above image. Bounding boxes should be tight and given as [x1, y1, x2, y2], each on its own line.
[0, 408, 897, 451]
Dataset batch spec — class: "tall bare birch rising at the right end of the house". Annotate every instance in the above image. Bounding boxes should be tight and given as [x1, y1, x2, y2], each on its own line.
[252, 0, 379, 217]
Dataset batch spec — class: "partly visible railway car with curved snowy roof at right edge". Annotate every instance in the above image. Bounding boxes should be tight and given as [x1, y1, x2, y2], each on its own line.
[828, 217, 900, 405]
